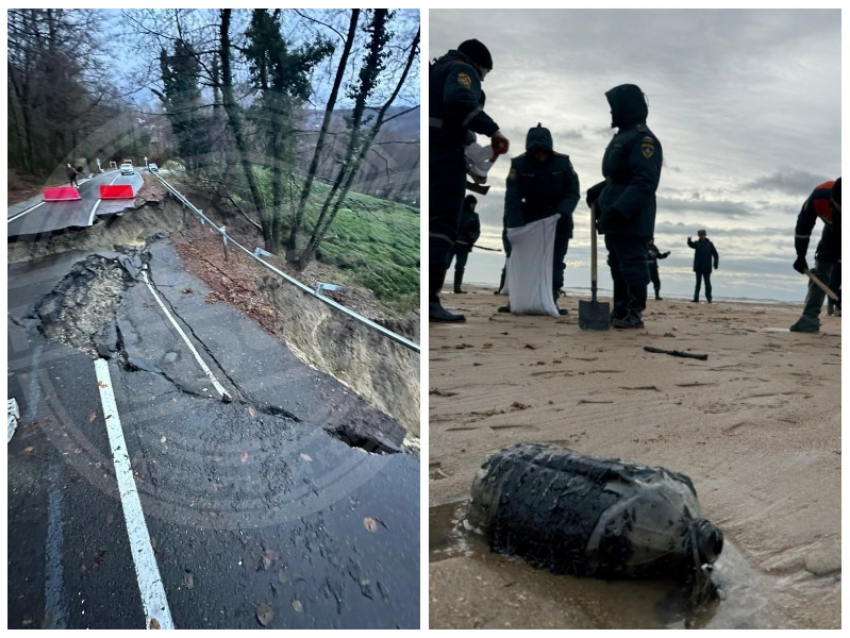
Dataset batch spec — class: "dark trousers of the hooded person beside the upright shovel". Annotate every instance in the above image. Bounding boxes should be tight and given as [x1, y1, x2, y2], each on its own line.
[605, 234, 650, 318]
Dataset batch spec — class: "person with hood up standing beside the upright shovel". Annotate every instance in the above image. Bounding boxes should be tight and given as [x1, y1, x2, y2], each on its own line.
[587, 84, 663, 328]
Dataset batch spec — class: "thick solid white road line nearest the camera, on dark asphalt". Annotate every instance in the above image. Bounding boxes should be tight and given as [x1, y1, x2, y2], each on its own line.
[94, 359, 174, 629]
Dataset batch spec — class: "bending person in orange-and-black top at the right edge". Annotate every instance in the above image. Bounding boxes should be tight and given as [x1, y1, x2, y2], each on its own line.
[791, 177, 841, 332]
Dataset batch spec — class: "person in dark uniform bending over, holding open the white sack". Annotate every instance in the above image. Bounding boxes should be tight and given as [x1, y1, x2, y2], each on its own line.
[499, 124, 581, 314]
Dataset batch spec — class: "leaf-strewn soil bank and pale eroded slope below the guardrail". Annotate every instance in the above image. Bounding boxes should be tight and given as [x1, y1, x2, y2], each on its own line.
[172, 209, 420, 450]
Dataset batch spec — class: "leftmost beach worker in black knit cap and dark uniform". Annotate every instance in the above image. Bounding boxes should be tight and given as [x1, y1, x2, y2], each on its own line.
[428, 40, 509, 322]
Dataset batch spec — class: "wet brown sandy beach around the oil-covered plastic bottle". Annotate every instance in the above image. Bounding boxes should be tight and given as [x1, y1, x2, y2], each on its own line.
[429, 287, 841, 628]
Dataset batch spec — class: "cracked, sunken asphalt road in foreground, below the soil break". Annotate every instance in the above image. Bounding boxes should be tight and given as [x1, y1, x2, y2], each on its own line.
[7, 241, 420, 628]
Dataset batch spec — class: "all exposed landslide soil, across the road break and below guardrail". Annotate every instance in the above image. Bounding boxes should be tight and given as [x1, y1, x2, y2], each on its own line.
[8, 188, 420, 452]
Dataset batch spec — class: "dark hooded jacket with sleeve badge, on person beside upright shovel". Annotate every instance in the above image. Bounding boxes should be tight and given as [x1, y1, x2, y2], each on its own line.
[587, 84, 663, 237]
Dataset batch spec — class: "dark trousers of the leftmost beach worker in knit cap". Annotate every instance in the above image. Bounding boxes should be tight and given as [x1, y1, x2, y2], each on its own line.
[428, 146, 466, 303]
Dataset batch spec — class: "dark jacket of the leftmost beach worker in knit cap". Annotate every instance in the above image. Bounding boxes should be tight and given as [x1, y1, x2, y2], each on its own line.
[428, 49, 499, 147]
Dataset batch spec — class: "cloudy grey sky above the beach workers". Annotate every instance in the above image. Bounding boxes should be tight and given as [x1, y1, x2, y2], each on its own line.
[428, 9, 841, 300]
